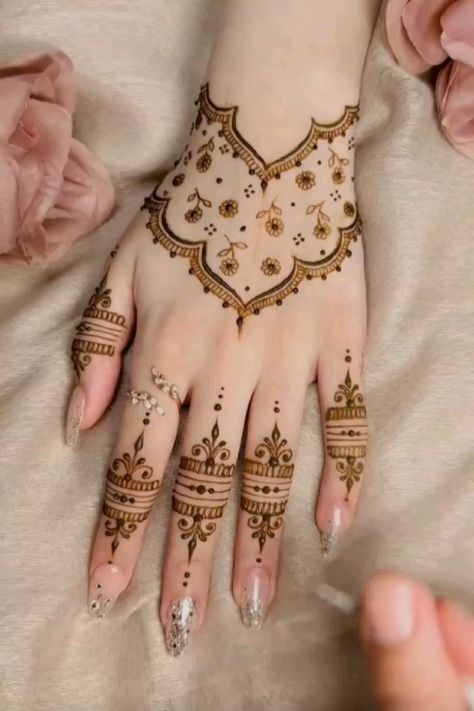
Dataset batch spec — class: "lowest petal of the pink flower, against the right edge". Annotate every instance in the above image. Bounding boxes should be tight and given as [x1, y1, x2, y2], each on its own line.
[436, 62, 474, 158]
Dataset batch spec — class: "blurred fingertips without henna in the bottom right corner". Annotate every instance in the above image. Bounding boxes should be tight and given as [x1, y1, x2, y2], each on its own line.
[360, 572, 474, 711]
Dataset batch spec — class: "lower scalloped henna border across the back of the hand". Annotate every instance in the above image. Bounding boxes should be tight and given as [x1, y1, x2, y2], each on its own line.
[144, 196, 361, 323]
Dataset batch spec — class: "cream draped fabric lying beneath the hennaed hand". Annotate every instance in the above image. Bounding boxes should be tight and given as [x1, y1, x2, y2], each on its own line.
[0, 0, 474, 711]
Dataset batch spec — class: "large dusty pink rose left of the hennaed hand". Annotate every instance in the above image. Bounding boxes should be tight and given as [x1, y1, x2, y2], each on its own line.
[0, 52, 114, 263]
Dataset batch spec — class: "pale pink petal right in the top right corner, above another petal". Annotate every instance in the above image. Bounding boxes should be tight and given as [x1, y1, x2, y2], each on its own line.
[441, 0, 474, 67]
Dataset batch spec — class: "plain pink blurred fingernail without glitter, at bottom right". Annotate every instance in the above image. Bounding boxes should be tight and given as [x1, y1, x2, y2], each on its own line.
[363, 580, 415, 647]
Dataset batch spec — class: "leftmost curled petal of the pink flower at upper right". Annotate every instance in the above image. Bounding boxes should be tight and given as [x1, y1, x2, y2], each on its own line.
[402, 0, 453, 66]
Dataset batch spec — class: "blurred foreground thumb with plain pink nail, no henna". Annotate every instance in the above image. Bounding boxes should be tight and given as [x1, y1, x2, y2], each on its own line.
[361, 573, 465, 711]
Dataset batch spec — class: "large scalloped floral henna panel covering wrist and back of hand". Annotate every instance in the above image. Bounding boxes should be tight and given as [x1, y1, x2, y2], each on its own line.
[144, 85, 361, 327]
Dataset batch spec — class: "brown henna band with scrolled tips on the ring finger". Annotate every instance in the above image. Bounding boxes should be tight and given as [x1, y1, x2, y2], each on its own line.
[240, 426, 294, 553]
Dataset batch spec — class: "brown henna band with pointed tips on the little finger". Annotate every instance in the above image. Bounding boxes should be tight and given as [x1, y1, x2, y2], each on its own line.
[325, 362, 367, 501]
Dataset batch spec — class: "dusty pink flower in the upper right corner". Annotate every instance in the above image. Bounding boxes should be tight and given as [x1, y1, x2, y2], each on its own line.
[384, 0, 474, 158]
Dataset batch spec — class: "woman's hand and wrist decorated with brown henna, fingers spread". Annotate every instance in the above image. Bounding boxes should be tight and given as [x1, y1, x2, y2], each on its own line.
[65, 0, 378, 654]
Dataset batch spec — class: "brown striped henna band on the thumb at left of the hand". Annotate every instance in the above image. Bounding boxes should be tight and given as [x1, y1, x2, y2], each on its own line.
[71, 272, 126, 377]
